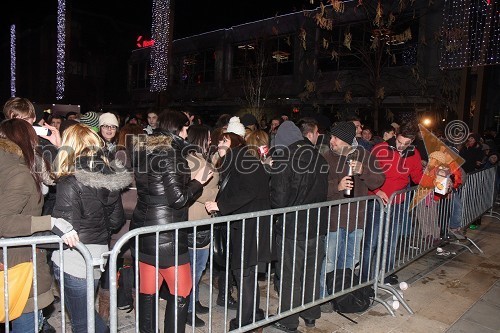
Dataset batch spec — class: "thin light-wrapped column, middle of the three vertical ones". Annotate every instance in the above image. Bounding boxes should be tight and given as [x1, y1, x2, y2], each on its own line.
[56, 0, 66, 100]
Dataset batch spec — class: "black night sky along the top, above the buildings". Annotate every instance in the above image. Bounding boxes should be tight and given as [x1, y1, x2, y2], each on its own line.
[0, 0, 310, 40]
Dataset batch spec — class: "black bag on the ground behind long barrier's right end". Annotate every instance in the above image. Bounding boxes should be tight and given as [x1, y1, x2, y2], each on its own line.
[327, 268, 375, 313]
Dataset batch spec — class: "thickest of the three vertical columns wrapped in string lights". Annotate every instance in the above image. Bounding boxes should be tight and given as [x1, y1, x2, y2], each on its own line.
[150, 0, 172, 92]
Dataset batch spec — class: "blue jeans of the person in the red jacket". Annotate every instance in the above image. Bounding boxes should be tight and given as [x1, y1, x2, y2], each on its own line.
[361, 197, 411, 282]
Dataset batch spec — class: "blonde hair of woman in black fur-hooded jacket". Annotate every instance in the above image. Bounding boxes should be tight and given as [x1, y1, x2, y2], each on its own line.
[53, 123, 107, 179]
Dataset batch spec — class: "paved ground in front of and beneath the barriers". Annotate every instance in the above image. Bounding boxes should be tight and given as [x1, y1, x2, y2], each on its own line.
[50, 211, 500, 333]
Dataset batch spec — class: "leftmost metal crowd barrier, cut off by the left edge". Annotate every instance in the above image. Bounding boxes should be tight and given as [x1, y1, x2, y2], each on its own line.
[0, 235, 95, 332]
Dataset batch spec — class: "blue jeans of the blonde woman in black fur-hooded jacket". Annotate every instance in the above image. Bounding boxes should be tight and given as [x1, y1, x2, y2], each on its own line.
[54, 264, 108, 333]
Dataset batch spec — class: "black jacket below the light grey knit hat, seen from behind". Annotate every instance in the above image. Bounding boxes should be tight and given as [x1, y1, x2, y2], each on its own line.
[271, 140, 328, 240]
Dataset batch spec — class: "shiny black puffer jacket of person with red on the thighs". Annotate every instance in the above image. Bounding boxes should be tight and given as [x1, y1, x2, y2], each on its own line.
[130, 132, 203, 268]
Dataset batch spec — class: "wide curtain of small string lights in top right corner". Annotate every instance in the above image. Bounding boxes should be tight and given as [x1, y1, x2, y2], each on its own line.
[439, 0, 500, 69]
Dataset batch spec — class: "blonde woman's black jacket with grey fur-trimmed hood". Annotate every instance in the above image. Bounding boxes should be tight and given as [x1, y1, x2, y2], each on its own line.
[52, 157, 132, 244]
